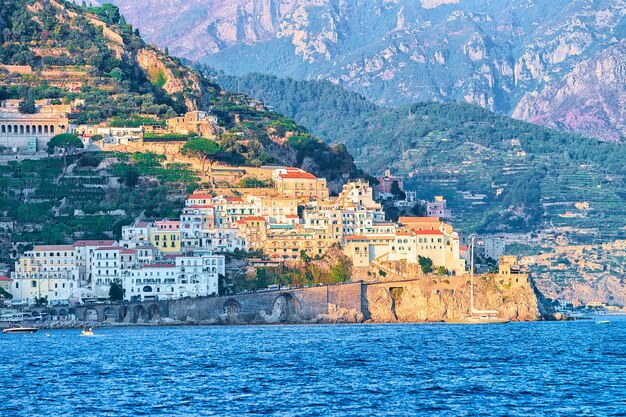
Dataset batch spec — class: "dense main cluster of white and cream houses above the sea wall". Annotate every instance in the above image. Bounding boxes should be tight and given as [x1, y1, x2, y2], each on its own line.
[8, 168, 467, 304]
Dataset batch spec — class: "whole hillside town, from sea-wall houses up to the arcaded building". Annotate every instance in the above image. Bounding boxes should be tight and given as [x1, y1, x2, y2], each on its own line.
[0, 92, 608, 316]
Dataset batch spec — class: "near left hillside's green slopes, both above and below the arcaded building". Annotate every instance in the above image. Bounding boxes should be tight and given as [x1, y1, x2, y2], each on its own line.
[0, 0, 361, 259]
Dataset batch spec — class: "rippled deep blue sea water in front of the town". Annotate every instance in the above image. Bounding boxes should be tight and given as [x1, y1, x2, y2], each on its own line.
[0, 318, 626, 417]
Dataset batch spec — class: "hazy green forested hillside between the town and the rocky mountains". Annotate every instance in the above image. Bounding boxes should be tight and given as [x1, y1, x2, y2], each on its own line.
[213, 73, 626, 242]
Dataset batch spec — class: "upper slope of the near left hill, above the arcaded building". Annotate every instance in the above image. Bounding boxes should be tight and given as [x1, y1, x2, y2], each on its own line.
[0, 0, 357, 185]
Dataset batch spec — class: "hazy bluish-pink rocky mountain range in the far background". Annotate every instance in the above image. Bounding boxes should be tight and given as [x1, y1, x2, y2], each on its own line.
[96, 0, 626, 141]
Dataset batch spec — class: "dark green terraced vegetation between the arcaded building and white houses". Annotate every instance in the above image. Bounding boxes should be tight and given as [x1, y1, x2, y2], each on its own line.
[0, 153, 198, 257]
